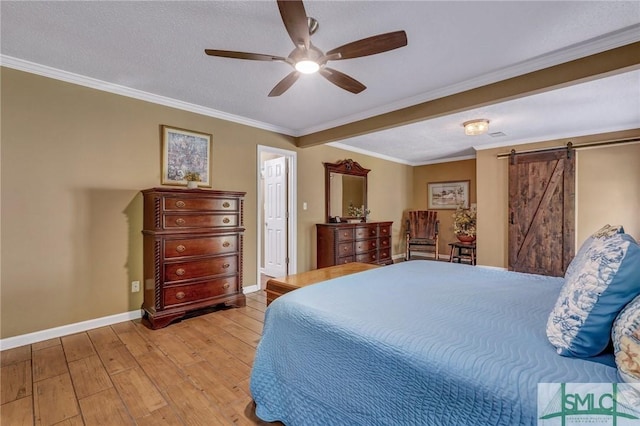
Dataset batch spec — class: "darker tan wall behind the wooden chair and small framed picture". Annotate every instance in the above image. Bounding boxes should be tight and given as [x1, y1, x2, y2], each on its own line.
[411, 160, 476, 254]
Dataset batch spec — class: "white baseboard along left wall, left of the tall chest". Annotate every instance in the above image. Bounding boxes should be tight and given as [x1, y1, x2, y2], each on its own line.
[0, 309, 142, 351]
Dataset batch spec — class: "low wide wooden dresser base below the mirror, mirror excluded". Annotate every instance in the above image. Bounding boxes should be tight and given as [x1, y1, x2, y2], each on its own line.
[316, 222, 393, 268]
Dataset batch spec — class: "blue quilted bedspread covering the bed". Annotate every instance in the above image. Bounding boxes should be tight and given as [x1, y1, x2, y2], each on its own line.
[251, 260, 617, 426]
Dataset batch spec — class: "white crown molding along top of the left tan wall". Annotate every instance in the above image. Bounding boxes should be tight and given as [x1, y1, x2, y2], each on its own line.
[0, 55, 297, 136]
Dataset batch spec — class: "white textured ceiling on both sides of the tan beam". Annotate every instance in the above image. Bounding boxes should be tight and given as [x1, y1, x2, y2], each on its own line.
[0, 1, 640, 164]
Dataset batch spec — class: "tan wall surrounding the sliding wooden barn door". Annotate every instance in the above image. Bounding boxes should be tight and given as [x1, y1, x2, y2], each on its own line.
[476, 131, 640, 268]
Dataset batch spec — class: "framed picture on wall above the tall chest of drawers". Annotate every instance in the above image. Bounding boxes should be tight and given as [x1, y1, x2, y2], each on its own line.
[161, 125, 212, 188]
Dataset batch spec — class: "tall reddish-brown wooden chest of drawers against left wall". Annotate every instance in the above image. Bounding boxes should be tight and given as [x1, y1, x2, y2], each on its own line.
[142, 188, 245, 329]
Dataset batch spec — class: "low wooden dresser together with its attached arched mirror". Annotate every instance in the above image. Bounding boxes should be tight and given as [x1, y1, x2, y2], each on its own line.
[316, 160, 393, 268]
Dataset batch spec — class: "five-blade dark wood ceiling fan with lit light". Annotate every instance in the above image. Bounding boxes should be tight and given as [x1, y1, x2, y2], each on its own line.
[205, 0, 407, 96]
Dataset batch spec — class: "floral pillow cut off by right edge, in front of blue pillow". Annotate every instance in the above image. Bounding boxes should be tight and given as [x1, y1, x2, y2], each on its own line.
[611, 296, 640, 383]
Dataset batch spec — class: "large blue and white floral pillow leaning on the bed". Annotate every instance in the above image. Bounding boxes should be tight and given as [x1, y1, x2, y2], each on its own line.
[547, 234, 640, 358]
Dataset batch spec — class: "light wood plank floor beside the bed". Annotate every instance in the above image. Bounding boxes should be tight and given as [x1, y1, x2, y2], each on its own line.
[0, 291, 282, 426]
